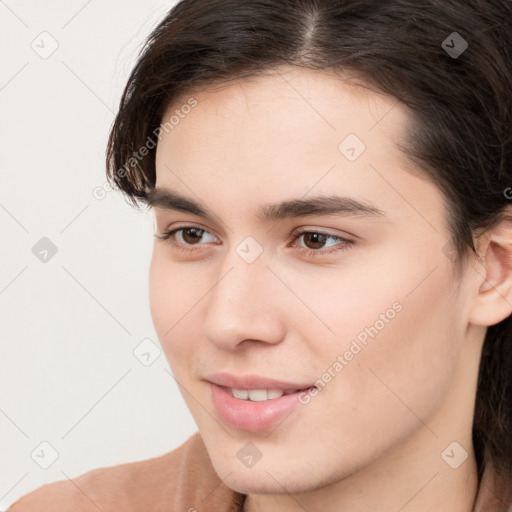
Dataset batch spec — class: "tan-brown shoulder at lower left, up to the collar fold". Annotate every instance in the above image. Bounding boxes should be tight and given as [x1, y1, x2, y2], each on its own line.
[7, 433, 201, 512]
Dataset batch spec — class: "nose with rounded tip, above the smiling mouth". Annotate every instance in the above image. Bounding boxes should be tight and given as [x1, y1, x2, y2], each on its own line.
[203, 251, 286, 350]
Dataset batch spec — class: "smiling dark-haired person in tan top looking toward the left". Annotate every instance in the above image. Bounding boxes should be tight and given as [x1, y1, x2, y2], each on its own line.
[10, 0, 512, 512]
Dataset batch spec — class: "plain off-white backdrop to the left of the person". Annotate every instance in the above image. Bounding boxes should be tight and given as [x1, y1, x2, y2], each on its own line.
[0, 0, 197, 510]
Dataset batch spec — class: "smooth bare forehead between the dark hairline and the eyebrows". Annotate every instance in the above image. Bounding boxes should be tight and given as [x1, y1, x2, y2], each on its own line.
[152, 68, 442, 233]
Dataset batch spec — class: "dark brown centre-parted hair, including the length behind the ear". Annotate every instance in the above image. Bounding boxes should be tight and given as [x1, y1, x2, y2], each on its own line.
[107, 0, 512, 496]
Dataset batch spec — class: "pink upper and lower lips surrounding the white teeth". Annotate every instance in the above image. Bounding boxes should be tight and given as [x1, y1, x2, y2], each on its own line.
[206, 374, 313, 432]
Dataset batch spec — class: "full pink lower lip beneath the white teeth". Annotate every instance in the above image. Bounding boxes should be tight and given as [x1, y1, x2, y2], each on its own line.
[210, 383, 307, 432]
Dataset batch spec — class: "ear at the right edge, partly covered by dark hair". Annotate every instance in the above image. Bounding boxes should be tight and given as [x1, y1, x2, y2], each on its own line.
[469, 210, 512, 326]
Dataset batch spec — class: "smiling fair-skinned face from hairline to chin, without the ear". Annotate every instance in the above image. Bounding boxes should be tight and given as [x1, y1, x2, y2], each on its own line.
[149, 68, 476, 493]
